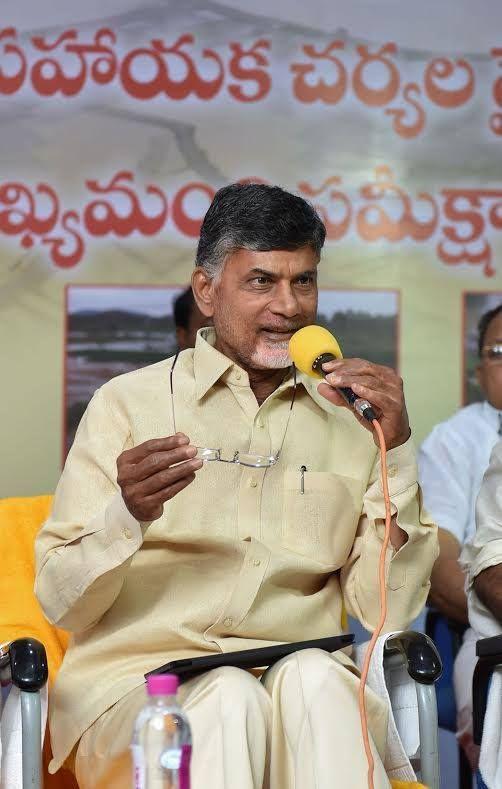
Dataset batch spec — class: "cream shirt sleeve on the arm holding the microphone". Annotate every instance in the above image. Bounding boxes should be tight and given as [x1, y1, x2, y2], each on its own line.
[340, 439, 439, 631]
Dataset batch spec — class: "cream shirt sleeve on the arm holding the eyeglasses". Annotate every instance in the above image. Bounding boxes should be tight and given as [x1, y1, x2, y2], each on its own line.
[35, 387, 145, 632]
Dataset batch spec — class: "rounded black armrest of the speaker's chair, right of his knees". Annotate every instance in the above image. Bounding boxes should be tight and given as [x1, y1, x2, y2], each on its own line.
[383, 630, 443, 685]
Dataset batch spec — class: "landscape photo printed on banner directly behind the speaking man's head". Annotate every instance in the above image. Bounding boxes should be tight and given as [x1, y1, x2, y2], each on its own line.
[64, 285, 399, 457]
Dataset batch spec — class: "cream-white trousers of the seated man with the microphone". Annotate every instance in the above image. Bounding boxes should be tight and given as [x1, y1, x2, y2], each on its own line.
[75, 649, 390, 789]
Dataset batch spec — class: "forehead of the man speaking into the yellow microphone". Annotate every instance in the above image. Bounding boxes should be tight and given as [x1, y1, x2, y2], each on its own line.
[224, 246, 318, 277]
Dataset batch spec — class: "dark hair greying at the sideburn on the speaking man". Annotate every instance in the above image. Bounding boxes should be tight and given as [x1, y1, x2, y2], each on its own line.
[195, 184, 326, 278]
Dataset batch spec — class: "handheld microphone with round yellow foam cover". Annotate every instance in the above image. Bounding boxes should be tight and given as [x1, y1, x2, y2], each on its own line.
[289, 326, 376, 422]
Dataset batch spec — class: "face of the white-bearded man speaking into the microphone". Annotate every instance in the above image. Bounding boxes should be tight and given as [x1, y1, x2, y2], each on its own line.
[192, 247, 317, 370]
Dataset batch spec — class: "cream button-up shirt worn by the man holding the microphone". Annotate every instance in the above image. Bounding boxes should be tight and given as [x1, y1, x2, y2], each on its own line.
[35, 330, 437, 768]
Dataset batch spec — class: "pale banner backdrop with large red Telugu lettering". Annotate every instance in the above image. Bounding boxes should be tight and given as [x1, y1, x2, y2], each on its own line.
[0, 0, 502, 495]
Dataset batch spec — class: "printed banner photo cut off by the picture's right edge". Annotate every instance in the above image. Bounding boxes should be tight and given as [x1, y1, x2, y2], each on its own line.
[463, 290, 502, 405]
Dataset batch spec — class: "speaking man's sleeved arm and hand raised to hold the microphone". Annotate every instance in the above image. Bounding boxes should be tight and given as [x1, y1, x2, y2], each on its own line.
[318, 359, 438, 632]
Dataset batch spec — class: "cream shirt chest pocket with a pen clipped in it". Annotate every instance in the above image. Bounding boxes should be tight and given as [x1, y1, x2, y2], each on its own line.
[282, 468, 363, 569]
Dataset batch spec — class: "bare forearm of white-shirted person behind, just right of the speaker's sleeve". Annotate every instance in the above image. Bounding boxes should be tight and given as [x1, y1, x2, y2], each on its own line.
[428, 528, 468, 624]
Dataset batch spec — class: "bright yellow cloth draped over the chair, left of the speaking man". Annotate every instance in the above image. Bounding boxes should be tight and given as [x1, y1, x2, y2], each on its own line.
[0, 496, 75, 789]
